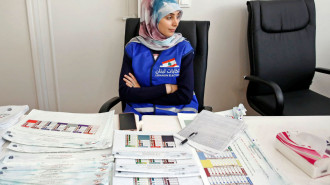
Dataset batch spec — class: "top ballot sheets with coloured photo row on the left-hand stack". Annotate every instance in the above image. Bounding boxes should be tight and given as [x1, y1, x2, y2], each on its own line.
[3, 109, 114, 149]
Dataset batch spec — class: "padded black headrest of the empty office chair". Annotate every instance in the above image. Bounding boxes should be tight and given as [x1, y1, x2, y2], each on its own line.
[260, 0, 309, 32]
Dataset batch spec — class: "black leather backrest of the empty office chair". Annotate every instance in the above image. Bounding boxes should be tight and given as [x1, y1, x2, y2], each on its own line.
[247, 0, 316, 94]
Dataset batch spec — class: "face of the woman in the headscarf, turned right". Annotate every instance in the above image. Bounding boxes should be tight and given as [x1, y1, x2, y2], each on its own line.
[158, 10, 181, 37]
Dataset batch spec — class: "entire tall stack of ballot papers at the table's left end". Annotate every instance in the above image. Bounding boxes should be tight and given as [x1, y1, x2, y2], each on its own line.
[0, 110, 114, 185]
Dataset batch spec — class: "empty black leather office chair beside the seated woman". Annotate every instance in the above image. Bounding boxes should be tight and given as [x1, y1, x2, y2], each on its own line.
[244, 0, 330, 116]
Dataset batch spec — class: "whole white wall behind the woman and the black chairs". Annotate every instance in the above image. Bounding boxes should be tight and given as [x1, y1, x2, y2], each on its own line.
[0, 0, 330, 115]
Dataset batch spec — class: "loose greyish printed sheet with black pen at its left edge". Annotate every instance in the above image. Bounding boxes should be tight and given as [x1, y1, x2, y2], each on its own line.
[174, 110, 246, 154]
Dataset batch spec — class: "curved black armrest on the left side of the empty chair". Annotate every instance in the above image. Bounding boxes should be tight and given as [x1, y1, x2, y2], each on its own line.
[244, 76, 284, 115]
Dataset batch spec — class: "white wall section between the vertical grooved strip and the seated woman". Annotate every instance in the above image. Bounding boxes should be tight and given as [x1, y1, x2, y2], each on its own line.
[51, 0, 127, 112]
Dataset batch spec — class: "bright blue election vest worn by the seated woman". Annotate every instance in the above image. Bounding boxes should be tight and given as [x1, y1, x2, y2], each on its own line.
[124, 41, 198, 118]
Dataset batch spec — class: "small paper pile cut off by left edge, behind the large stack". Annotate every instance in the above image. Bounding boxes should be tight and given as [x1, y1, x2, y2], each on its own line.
[0, 105, 29, 148]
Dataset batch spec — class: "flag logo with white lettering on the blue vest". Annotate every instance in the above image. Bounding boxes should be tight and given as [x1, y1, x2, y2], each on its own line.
[155, 58, 180, 77]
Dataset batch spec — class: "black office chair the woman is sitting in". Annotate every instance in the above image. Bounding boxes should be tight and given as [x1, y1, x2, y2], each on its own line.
[99, 18, 212, 113]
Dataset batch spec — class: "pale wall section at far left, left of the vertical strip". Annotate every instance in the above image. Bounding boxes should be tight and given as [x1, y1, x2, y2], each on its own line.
[0, 0, 38, 108]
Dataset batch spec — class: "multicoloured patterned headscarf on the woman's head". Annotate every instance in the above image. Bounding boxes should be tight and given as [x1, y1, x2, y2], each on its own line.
[130, 0, 185, 51]
